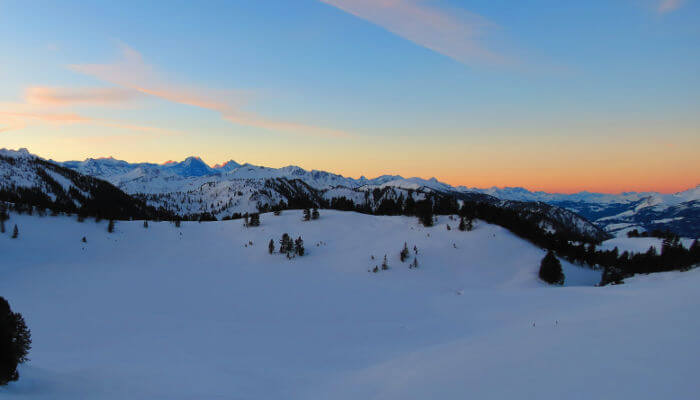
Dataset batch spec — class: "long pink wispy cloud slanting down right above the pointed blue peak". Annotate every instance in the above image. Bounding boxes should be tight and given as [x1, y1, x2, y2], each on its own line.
[70, 45, 347, 137]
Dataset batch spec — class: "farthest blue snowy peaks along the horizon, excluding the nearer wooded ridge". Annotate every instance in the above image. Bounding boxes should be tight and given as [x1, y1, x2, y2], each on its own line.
[56, 152, 700, 237]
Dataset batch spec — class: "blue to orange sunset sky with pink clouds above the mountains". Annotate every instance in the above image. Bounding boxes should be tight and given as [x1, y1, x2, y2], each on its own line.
[0, 0, 700, 193]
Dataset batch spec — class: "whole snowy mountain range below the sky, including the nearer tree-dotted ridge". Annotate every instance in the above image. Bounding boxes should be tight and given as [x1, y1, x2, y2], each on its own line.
[0, 149, 700, 237]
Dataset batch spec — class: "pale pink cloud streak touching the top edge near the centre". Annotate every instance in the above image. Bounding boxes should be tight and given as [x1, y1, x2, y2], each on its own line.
[319, 0, 511, 65]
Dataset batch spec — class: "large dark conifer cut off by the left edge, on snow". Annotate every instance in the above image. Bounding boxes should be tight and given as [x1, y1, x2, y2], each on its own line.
[0, 296, 32, 386]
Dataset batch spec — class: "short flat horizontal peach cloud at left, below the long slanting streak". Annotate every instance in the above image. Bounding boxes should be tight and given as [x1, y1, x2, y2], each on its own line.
[24, 86, 139, 106]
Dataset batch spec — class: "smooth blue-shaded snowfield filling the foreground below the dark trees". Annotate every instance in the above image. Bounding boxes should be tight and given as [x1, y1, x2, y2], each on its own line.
[0, 210, 700, 400]
